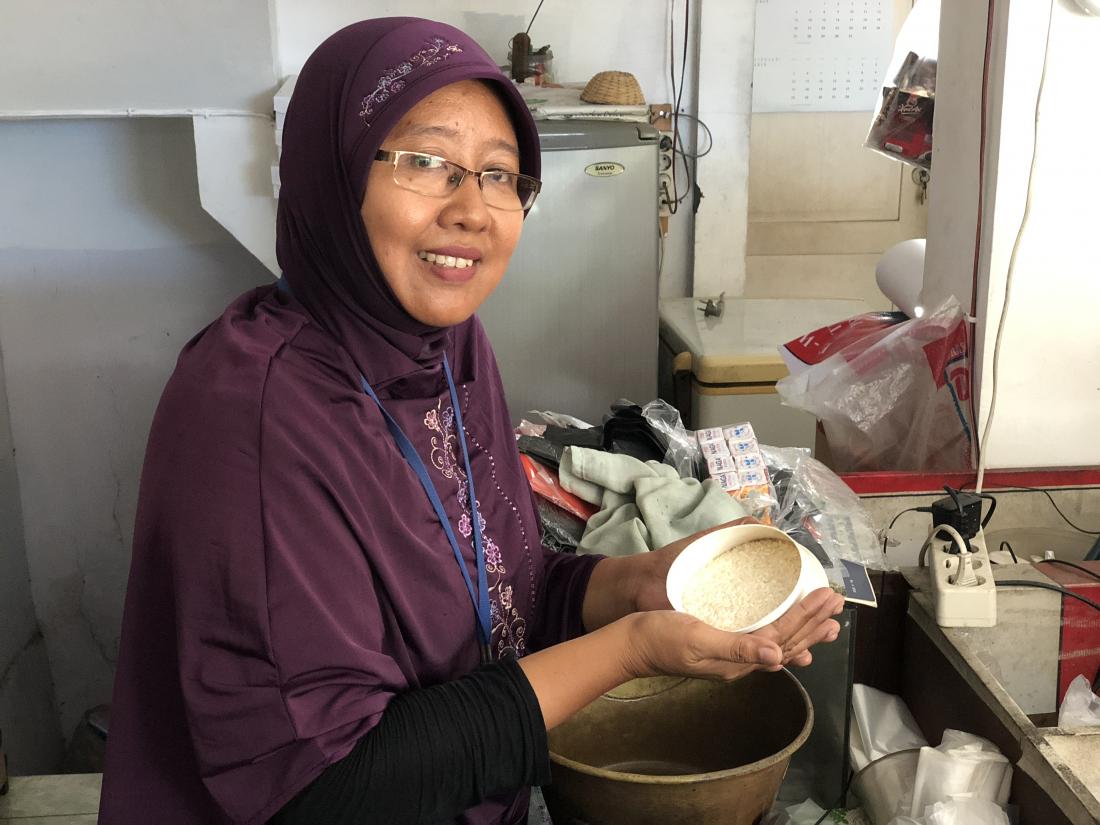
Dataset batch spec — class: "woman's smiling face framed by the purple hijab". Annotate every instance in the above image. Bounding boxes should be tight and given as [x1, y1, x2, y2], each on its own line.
[360, 80, 524, 327]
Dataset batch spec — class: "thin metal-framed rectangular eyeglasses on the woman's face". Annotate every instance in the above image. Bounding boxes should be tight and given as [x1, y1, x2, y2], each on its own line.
[374, 150, 542, 212]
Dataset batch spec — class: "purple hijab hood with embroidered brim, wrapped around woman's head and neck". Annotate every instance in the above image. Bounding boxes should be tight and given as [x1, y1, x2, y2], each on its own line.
[276, 18, 541, 389]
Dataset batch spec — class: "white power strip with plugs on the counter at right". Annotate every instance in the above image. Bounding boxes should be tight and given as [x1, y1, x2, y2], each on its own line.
[928, 534, 997, 627]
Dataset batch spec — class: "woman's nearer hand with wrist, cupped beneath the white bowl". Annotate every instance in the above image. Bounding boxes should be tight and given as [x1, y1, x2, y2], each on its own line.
[623, 587, 844, 681]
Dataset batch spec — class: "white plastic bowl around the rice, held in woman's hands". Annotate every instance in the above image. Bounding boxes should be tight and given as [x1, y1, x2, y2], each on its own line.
[664, 525, 829, 634]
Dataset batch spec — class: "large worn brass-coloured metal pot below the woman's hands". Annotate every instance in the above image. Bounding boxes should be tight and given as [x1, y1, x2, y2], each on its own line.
[543, 670, 814, 825]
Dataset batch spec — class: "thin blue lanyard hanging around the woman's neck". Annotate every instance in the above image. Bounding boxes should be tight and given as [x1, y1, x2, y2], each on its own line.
[277, 277, 493, 662]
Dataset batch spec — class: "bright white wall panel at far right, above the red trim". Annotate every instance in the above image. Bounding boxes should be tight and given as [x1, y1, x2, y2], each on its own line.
[977, 0, 1100, 468]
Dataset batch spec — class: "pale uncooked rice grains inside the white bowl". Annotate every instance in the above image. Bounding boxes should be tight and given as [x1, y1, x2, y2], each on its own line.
[683, 538, 802, 630]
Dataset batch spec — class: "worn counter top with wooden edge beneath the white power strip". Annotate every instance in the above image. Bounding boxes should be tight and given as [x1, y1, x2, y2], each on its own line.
[901, 564, 1100, 825]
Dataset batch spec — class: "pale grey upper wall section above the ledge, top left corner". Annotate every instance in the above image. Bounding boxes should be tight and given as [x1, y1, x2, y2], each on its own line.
[0, 0, 274, 112]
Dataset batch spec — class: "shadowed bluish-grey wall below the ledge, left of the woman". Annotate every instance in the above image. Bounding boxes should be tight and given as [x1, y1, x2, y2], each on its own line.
[0, 119, 270, 765]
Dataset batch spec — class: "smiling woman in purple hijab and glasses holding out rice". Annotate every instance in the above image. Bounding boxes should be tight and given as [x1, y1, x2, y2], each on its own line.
[100, 18, 840, 825]
